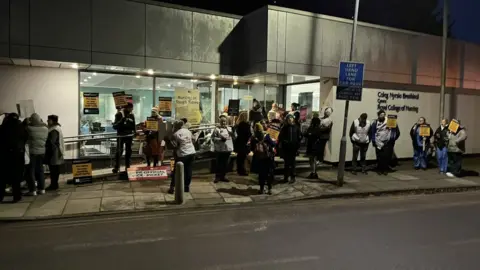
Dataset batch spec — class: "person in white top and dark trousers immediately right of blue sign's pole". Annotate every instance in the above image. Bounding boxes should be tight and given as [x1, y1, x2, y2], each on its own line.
[349, 113, 371, 175]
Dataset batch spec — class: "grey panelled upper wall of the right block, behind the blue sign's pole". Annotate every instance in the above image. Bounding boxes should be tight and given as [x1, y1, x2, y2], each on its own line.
[267, 6, 480, 89]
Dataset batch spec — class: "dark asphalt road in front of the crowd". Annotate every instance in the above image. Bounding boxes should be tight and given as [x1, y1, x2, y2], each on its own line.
[0, 193, 480, 270]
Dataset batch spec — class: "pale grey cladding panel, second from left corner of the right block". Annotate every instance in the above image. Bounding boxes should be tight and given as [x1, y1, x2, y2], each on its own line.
[286, 13, 323, 65]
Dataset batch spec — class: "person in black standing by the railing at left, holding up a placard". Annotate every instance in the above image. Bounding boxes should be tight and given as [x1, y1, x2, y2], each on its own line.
[112, 103, 135, 173]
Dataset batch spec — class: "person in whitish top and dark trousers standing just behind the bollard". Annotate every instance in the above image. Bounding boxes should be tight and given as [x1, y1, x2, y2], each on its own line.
[168, 121, 197, 194]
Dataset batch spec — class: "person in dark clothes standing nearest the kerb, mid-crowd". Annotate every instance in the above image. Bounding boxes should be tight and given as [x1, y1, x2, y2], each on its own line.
[250, 123, 275, 195]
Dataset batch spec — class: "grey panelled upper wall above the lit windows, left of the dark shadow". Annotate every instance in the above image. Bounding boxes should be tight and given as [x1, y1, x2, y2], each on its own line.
[0, 0, 240, 74]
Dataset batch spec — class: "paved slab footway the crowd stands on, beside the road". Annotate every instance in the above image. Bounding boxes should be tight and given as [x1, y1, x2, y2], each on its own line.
[0, 159, 480, 220]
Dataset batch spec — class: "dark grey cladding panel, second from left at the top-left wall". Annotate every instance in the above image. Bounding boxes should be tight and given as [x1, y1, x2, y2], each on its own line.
[30, 0, 91, 51]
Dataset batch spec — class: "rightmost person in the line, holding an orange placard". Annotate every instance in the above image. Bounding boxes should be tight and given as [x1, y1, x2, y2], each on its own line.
[447, 121, 467, 177]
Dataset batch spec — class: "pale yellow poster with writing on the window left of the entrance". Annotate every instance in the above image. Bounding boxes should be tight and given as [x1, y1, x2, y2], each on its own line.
[175, 88, 202, 125]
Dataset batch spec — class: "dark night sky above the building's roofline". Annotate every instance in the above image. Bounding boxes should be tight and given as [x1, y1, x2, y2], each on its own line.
[162, 0, 480, 44]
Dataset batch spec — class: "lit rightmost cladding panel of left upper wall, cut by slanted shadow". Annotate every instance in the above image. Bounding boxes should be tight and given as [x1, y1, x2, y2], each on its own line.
[193, 12, 234, 63]
